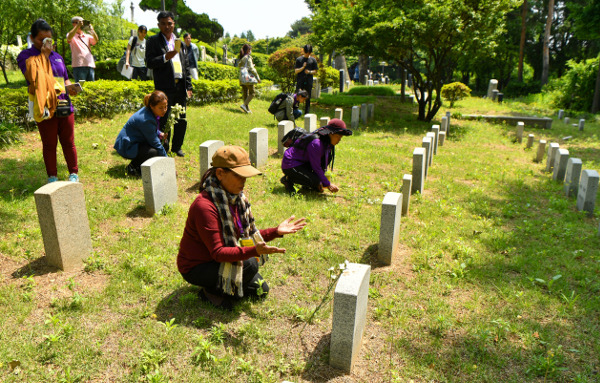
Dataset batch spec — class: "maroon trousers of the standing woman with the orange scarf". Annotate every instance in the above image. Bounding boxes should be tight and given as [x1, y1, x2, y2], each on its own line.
[37, 113, 79, 177]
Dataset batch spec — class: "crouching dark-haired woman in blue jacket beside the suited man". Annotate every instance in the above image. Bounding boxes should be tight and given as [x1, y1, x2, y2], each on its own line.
[113, 90, 168, 177]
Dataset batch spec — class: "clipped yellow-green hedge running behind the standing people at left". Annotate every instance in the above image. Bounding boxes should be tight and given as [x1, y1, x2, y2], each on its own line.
[0, 79, 273, 129]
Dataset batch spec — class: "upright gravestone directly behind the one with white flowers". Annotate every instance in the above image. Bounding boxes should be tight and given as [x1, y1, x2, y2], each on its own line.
[378, 192, 402, 265]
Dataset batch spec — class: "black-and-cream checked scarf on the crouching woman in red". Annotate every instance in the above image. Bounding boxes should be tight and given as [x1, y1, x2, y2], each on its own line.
[202, 174, 269, 298]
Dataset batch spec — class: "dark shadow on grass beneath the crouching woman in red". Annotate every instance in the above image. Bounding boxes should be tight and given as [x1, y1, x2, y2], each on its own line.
[154, 285, 243, 328]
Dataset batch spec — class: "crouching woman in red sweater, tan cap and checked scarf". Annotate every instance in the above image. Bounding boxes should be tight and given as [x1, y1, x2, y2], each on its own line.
[177, 146, 306, 310]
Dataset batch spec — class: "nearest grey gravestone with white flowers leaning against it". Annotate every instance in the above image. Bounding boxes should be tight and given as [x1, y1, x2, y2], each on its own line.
[329, 263, 371, 373]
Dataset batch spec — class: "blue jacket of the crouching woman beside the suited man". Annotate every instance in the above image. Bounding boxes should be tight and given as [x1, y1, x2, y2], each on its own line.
[114, 106, 167, 160]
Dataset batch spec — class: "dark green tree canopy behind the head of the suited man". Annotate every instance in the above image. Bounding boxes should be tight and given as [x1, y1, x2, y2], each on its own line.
[140, 0, 223, 43]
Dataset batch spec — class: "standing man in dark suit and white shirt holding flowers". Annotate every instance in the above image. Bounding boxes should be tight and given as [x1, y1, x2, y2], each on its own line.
[146, 11, 192, 157]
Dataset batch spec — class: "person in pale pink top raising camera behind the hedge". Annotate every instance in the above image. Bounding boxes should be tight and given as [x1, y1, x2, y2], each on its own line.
[67, 16, 98, 82]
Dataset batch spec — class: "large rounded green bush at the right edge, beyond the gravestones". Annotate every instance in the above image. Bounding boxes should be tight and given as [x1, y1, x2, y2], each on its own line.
[543, 56, 600, 111]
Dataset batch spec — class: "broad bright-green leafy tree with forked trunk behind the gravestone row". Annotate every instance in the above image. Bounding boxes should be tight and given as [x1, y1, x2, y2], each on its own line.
[307, 0, 520, 121]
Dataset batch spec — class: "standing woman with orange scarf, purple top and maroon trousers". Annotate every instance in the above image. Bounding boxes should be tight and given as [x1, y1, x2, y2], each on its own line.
[17, 19, 79, 183]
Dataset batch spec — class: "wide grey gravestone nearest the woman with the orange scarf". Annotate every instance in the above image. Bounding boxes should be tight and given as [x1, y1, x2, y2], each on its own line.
[34, 181, 92, 270]
